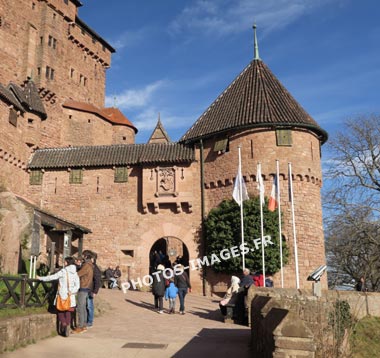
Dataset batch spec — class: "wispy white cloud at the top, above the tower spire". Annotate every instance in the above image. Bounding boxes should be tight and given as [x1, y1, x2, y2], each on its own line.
[169, 0, 328, 36]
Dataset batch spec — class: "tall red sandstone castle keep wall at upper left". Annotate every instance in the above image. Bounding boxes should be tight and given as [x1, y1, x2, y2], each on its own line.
[0, 0, 111, 147]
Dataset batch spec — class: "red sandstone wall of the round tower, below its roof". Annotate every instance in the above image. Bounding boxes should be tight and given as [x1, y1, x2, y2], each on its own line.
[205, 130, 327, 287]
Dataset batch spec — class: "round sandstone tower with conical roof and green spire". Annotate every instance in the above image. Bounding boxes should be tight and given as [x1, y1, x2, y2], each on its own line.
[180, 27, 327, 288]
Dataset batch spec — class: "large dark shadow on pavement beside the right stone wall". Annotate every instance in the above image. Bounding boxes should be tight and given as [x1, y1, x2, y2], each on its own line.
[172, 328, 252, 358]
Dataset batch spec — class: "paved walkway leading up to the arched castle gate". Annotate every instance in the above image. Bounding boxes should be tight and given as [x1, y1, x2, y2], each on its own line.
[1, 289, 254, 358]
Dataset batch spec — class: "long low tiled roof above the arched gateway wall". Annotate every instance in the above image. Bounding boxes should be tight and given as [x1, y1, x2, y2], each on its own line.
[28, 143, 195, 169]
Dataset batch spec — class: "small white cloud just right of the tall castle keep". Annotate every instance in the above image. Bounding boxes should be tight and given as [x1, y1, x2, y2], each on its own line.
[106, 80, 165, 109]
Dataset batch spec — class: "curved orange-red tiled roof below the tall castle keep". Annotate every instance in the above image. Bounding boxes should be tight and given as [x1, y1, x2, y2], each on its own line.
[63, 99, 137, 133]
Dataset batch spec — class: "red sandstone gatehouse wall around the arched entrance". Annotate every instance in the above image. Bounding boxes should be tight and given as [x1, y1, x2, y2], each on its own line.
[28, 163, 205, 292]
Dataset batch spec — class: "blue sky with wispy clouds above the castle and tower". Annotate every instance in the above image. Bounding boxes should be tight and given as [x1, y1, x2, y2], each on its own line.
[79, 0, 380, 155]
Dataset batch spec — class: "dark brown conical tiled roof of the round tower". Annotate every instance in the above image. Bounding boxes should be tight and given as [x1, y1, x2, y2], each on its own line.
[180, 59, 327, 142]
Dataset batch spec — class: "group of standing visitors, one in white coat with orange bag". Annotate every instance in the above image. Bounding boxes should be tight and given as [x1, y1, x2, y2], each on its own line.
[37, 250, 101, 337]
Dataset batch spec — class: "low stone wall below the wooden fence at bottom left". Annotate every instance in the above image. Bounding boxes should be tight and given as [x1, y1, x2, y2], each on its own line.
[0, 313, 56, 354]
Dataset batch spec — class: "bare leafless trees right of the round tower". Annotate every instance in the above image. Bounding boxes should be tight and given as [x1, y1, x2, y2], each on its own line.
[324, 115, 380, 291]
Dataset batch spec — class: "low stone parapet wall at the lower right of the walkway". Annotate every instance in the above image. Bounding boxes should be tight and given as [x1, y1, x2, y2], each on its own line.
[248, 287, 380, 358]
